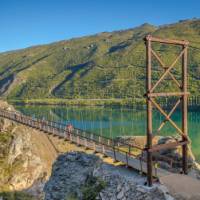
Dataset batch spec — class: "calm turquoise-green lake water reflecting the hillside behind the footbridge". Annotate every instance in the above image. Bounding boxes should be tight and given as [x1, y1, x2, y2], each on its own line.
[16, 106, 200, 160]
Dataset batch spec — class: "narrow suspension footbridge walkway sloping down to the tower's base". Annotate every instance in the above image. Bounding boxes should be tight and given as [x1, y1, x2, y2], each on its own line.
[0, 109, 173, 178]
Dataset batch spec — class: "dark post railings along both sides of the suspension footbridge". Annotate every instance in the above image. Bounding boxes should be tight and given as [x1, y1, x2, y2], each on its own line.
[0, 109, 177, 175]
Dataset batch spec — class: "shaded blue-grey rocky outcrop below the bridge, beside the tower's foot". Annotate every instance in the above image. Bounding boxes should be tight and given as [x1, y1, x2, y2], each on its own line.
[44, 152, 173, 200]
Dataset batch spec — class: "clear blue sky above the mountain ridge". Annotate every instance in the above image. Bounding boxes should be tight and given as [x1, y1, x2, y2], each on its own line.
[0, 0, 200, 52]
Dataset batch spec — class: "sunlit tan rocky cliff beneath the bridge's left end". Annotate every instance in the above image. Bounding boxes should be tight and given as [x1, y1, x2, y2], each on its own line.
[0, 101, 57, 196]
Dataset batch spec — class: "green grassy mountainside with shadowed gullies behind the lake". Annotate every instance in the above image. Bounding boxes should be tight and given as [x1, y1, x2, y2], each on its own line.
[0, 19, 200, 102]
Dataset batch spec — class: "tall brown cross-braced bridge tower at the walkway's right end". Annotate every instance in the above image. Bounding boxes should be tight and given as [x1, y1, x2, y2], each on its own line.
[145, 35, 189, 186]
